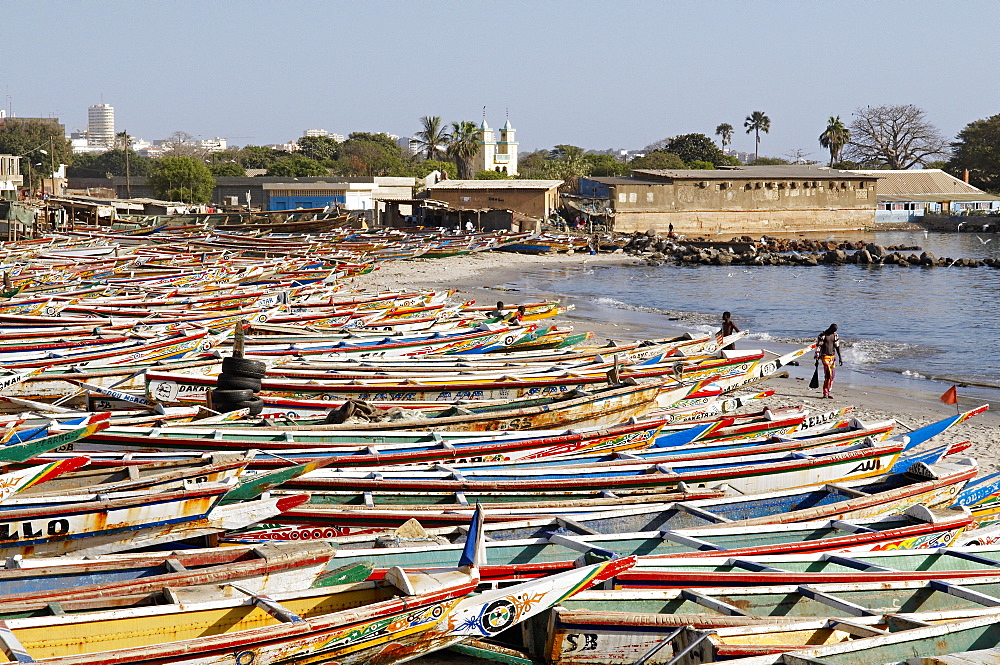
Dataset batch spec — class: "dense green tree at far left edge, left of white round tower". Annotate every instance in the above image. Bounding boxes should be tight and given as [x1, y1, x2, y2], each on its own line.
[0, 118, 73, 188]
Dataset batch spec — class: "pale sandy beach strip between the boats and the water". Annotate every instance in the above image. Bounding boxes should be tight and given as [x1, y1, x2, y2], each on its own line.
[348, 252, 1000, 474]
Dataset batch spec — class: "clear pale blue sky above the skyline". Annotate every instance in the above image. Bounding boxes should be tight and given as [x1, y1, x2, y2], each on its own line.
[0, 0, 1000, 160]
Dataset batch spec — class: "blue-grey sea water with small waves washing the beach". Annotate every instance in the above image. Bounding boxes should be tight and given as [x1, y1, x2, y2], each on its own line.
[508, 232, 1000, 398]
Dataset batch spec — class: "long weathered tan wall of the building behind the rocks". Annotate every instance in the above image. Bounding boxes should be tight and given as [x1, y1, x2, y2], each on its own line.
[609, 178, 875, 236]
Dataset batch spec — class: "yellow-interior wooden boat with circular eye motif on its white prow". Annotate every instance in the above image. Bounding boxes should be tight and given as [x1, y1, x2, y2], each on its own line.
[4, 508, 633, 665]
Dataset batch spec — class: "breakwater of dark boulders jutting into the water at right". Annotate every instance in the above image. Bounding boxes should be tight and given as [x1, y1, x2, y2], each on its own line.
[625, 234, 1000, 268]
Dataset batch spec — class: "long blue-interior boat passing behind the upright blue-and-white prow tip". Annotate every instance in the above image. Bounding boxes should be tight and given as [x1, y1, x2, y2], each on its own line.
[250, 452, 976, 540]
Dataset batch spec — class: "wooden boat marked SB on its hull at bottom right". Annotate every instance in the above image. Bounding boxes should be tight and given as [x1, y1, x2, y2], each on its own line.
[544, 576, 1000, 665]
